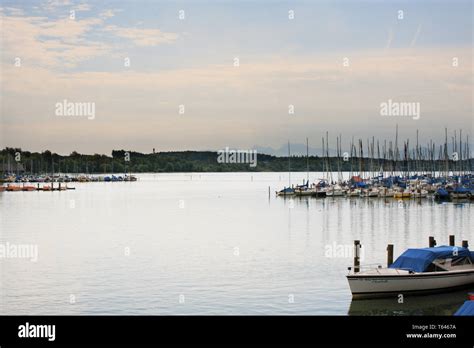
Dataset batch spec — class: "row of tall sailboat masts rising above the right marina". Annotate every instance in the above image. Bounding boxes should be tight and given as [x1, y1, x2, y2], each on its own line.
[288, 125, 472, 187]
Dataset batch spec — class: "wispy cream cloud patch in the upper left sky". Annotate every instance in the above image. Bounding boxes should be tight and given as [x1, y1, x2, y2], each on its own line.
[0, 6, 178, 69]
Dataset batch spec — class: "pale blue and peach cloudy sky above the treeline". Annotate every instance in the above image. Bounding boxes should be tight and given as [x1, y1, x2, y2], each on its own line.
[0, 0, 474, 154]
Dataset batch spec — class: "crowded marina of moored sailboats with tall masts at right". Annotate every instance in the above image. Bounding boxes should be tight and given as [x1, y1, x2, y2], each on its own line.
[276, 130, 474, 200]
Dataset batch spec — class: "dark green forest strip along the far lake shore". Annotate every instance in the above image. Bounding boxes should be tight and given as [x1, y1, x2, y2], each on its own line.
[0, 148, 474, 174]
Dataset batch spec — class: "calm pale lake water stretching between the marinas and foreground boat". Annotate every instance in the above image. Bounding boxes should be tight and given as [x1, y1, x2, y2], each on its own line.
[0, 173, 474, 315]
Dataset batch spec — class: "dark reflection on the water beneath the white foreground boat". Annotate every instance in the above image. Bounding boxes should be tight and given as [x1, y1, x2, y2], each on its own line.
[348, 288, 474, 316]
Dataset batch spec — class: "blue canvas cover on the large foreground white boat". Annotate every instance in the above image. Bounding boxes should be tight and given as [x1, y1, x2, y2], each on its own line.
[389, 245, 472, 272]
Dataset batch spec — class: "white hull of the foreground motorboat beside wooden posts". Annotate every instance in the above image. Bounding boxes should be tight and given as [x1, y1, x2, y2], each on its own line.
[347, 269, 474, 299]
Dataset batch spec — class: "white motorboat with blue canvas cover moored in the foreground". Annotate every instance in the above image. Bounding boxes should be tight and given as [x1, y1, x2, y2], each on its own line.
[347, 246, 474, 299]
